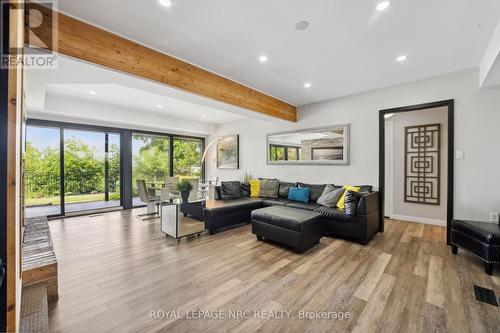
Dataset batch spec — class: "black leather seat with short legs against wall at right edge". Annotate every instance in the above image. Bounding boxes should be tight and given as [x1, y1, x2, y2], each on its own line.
[451, 220, 500, 275]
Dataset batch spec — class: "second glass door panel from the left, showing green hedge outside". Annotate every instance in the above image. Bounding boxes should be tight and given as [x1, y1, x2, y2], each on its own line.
[64, 129, 121, 213]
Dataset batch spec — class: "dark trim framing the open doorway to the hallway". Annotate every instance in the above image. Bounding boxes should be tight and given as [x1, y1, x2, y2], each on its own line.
[378, 99, 455, 245]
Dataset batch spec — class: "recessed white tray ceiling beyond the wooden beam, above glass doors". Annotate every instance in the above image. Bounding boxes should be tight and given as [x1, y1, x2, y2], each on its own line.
[25, 56, 249, 125]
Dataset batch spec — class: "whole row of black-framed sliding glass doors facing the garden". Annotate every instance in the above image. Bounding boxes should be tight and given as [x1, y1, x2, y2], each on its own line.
[24, 120, 205, 217]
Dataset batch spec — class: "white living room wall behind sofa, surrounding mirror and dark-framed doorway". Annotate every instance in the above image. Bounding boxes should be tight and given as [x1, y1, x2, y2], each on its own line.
[207, 69, 500, 220]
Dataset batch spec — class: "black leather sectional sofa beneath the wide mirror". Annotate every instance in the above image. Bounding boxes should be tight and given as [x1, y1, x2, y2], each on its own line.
[204, 183, 379, 245]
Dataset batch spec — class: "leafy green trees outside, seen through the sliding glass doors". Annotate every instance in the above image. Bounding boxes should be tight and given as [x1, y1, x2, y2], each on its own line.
[25, 134, 202, 206]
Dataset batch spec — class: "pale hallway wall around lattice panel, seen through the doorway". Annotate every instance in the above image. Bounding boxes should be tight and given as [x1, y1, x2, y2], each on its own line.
[385, 107, 448, 225]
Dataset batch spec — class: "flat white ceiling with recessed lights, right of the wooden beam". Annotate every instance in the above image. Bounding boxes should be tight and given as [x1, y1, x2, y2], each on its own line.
[59, 0, 500, 105]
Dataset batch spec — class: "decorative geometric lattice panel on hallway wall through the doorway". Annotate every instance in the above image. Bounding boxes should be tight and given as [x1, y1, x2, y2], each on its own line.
[404, 124, 441, 205]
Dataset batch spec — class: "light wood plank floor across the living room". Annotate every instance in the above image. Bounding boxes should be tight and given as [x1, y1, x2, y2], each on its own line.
[49, 211, 500, 333]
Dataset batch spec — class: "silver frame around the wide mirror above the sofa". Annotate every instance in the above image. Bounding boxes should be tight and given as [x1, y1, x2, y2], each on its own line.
[266, 124, 351, 165]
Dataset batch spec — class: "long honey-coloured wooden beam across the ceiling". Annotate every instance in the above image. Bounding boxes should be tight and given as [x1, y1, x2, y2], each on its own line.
[26, 3, 297, 122]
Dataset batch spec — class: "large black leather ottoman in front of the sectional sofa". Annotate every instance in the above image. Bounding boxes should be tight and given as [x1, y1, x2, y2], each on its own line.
[252, 206, 324, 253]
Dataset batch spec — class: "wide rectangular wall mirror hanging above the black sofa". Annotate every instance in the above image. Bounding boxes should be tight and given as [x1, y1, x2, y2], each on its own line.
[267, 124, 349, 165]
